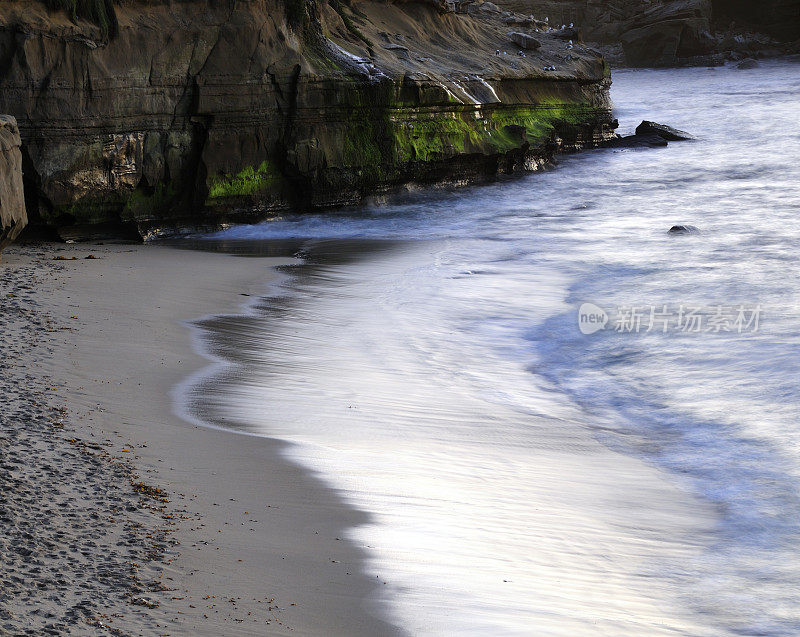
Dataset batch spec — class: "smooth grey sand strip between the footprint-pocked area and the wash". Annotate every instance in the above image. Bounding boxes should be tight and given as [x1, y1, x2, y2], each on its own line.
[0, 244, 400, 635]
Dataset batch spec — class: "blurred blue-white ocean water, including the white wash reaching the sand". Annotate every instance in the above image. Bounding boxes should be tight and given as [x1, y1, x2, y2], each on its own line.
[182, 60, 800, 636]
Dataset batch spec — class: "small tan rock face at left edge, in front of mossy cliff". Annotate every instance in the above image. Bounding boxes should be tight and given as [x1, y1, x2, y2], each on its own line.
[0, 115, 28, 250]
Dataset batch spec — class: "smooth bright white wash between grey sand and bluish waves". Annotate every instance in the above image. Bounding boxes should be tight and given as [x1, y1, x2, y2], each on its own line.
[180, 236, 713, 635]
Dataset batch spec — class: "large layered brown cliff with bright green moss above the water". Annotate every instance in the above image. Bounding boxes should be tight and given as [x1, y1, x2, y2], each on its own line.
[0, 0, 614, 236]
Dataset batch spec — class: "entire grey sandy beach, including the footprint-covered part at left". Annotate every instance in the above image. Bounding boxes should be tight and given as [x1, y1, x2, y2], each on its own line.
[0, 244, 399, 636]
